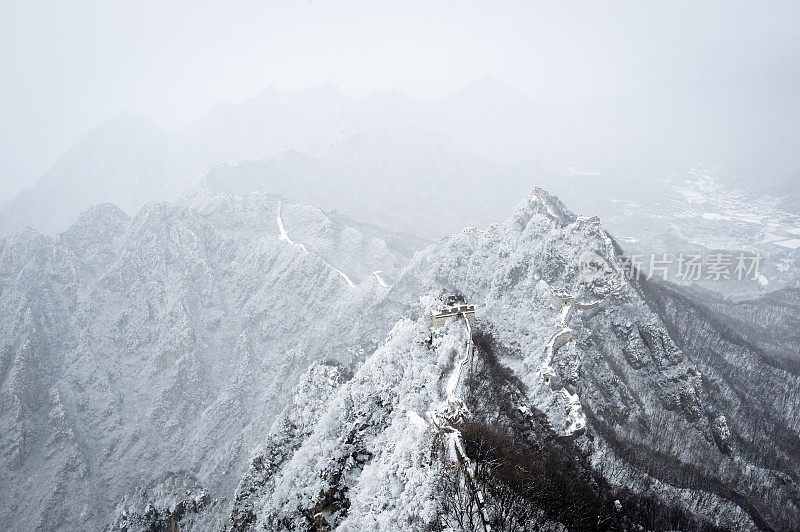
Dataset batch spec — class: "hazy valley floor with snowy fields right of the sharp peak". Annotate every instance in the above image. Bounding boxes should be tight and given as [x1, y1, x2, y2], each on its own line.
[601, 170, 800, 297]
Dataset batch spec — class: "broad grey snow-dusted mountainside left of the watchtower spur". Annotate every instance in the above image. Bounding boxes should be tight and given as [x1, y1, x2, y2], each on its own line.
[0, 195, 416, 530]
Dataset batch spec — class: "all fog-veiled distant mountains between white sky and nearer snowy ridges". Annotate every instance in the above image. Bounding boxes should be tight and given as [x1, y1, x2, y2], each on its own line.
[0, 65, 800, 247]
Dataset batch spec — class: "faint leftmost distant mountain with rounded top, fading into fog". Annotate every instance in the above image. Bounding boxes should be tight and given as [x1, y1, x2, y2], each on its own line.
[0, 115, 200, 235]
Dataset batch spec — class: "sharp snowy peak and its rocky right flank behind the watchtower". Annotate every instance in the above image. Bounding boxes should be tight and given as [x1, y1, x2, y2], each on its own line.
[228, 190, 798, 530]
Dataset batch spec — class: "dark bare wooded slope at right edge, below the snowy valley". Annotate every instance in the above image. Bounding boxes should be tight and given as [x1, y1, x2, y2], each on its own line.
[643, 283, 800, 529]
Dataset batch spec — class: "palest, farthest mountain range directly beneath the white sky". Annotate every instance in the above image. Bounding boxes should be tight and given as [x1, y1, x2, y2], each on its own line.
[0, 68, 800, 233]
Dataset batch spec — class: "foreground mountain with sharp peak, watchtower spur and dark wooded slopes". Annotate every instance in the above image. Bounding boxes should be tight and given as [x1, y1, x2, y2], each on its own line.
[231, 191, 799, 530]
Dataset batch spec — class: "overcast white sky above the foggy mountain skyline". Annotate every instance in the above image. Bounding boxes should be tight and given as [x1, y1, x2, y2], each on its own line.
[0, 0, 800, 201]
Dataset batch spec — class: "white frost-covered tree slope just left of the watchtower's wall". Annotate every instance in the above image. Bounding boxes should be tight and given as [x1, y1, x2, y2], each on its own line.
[230, 322, 438, 529]
